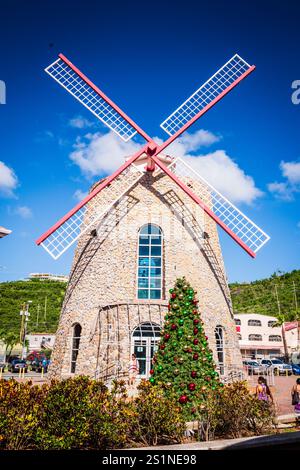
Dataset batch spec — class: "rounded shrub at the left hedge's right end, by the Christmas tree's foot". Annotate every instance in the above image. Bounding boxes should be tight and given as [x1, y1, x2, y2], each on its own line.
[134, 381, 185, 445]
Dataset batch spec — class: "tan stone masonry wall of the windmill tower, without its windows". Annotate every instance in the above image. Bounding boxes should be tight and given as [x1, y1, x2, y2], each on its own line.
[49, 173, 241, 377]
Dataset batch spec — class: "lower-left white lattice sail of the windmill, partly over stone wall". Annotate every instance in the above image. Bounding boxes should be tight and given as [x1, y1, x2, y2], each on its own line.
[41, 165, 144, 259]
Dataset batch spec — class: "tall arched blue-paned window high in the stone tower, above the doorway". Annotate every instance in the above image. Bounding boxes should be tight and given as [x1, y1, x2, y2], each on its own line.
[137, 224, 163, 299]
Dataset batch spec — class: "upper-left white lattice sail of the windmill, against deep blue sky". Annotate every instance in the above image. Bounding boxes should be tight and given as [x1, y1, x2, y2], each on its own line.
[45, 58, 137, 142]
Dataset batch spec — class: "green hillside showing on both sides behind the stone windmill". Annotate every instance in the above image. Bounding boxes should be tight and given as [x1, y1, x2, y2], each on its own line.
[0, 270, 300, 342]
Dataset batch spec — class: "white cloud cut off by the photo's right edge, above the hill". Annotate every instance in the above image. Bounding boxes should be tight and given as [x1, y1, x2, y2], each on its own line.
[268, 161, 300, 201]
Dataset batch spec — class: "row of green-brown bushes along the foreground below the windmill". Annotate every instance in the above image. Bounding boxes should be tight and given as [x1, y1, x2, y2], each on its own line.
[0, 376, 274, 450]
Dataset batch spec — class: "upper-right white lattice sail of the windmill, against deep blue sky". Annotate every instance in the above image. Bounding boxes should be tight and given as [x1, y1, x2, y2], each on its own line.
[160, 54, 251, 136]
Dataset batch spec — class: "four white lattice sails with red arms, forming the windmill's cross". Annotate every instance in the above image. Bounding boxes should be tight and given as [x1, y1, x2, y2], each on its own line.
[36, 54, 269, 382]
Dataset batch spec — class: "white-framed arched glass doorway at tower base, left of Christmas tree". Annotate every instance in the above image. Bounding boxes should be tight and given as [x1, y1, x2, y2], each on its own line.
[131, 322, 160, 378]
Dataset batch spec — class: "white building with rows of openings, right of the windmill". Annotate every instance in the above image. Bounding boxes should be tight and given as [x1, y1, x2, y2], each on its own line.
[234, 313, 284, 359]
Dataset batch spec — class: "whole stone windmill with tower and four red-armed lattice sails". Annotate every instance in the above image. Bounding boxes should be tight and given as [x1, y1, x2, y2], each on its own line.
[37, 54, 269, 379]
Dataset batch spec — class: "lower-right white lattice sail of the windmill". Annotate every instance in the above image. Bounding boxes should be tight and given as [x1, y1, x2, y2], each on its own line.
[168, 157, 270, 253]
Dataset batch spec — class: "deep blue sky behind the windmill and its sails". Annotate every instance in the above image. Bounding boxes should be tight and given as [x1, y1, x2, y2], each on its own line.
[0, 0, 300, 281]
